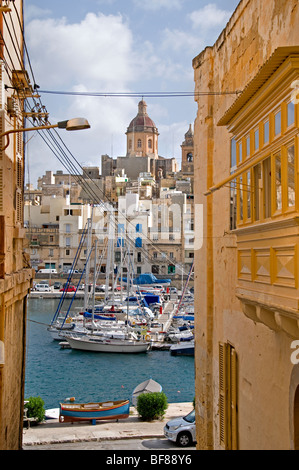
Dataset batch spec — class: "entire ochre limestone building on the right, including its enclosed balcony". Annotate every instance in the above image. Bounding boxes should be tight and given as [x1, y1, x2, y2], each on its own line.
[193, 0, 299, 450]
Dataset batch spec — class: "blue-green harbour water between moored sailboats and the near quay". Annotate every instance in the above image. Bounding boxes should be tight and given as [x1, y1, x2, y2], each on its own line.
[25, 298, 194, 409]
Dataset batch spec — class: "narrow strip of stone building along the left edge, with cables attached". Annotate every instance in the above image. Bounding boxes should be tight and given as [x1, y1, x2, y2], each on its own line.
[0, 0, 33, 450]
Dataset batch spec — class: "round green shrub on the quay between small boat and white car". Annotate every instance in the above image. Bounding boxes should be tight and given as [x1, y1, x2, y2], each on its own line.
[137, 392, 168, 421]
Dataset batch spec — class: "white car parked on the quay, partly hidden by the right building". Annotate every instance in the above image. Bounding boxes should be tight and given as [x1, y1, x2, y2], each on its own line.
[164, 409, 196, 447]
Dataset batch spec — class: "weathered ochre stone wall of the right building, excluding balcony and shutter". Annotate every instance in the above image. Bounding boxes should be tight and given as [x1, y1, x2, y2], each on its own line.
[193, 0, 299, 449]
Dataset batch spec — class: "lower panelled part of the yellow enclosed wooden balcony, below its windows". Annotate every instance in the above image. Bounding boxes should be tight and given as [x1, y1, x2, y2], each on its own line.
[236, 217, 299, 338]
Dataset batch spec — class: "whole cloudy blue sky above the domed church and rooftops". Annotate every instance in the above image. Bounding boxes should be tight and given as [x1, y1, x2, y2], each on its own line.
[24, 0, 239, 187]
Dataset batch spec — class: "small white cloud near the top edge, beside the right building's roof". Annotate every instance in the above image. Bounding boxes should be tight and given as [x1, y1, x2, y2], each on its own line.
[188, 3, 231, 30]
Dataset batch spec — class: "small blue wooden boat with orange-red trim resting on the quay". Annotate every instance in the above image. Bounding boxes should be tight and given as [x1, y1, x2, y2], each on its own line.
[59, 400, 130, 424]
